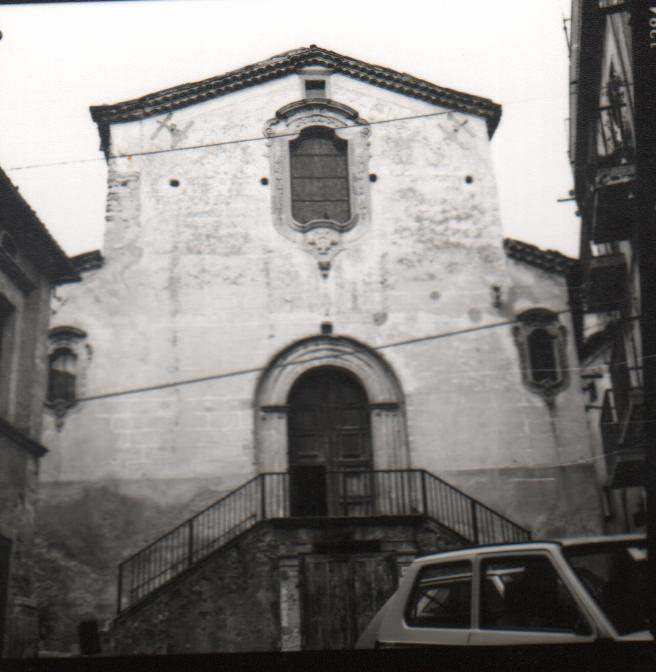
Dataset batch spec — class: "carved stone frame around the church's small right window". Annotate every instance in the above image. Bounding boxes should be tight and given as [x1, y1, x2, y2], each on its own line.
[512, 308, 569, 408]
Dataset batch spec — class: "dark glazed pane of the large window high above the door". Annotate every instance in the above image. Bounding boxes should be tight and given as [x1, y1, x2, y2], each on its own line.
[289, 126, 351, 224]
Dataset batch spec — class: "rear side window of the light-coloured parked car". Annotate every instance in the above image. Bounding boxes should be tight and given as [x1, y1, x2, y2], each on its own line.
[405, 561, 472, 628]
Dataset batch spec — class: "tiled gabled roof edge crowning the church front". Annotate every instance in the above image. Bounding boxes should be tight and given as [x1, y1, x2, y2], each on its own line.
[90, 44, 501, 136]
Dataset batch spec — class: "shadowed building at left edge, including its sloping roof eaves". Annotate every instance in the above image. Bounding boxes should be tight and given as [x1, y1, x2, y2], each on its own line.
[0, 170, 79, 657]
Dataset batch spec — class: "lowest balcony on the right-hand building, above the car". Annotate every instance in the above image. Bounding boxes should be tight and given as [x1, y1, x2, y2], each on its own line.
[600, 390, 645, 489]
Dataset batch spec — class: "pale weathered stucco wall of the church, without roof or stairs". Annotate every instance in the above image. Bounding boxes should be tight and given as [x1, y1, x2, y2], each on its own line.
[34, 51, 600, 643]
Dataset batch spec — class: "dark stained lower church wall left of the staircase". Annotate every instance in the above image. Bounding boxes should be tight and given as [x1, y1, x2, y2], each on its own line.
[33, 483, 226, 653]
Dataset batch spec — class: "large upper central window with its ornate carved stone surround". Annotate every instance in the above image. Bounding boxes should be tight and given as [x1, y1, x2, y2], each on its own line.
[264, 99, 370, 277]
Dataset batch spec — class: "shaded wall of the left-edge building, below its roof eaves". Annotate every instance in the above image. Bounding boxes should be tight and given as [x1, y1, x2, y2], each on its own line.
[0, 234, 59, 657]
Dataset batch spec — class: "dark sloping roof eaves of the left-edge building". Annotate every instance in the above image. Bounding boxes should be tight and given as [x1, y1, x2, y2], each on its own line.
[0, 169, 80, 284]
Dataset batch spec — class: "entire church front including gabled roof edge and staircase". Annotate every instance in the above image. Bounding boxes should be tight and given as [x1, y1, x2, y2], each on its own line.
[34, 46, 601, 653]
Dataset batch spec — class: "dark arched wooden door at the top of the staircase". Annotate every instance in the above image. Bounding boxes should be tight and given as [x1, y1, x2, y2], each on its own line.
[288, 366, 373, 516]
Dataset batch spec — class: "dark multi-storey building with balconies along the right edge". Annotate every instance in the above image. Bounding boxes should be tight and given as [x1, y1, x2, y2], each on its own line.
[569, 0, 647, 532]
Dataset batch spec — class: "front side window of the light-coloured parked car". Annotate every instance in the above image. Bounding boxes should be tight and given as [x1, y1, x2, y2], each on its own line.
[480, 555, 591, 635]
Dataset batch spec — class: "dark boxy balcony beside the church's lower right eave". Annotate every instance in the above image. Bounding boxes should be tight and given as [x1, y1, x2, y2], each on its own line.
[583, 253, 627, 313]
